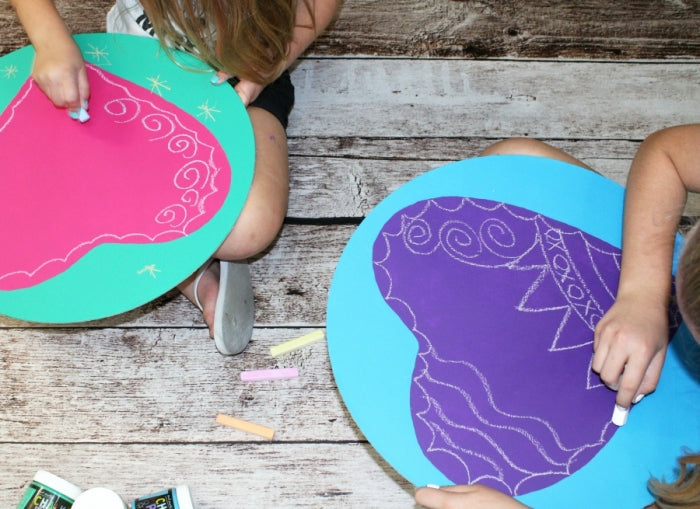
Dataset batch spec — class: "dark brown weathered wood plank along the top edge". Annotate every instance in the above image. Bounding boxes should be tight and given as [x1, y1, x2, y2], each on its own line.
[0, 0, 700, 59]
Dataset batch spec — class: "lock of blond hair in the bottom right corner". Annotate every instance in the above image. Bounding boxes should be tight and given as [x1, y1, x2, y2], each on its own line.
[649, 454, 700, 509]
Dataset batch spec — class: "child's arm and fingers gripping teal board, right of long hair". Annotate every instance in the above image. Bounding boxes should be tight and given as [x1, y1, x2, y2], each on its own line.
[228, 0, 342, 106]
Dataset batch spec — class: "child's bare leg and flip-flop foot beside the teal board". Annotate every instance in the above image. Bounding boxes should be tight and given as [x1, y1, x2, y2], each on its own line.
[178, 107, 289, 337]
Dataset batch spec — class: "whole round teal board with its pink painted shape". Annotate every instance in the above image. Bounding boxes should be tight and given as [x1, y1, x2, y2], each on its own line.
[0, 33, 255, 323]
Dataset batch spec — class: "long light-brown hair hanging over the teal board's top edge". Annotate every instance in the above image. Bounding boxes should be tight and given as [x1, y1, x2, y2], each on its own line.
[141, 0, 313, 84]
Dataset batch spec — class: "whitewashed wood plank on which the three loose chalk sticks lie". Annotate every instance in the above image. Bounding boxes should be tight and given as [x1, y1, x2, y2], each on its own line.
[0, 328, 364, 444]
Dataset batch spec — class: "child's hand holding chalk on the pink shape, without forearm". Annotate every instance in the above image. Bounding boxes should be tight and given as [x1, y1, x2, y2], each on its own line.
[32, 33, 90, 114]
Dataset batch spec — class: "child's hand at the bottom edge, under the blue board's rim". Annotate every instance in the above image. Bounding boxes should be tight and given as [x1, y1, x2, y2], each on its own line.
[415, 484, 527, 509]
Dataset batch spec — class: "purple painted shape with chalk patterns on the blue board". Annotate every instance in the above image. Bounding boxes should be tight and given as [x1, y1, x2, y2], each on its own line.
[373, 197, 620, 495]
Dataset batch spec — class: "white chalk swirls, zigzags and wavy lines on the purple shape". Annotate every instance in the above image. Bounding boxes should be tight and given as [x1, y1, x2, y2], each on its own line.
[373, 199, 619, 494]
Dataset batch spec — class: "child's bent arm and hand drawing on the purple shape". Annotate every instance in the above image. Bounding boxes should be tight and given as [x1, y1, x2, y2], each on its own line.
[592, 124, 700, 408]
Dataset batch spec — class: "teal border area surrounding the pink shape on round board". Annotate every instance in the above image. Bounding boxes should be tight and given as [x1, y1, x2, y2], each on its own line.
[0, 33, 255, 323]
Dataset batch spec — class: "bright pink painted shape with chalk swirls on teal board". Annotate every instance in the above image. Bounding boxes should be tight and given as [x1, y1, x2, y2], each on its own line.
[0, 64, 231, 290]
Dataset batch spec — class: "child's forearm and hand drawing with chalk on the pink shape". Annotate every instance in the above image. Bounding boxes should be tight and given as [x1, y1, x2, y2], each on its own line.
[10, 0, 90, 112]
